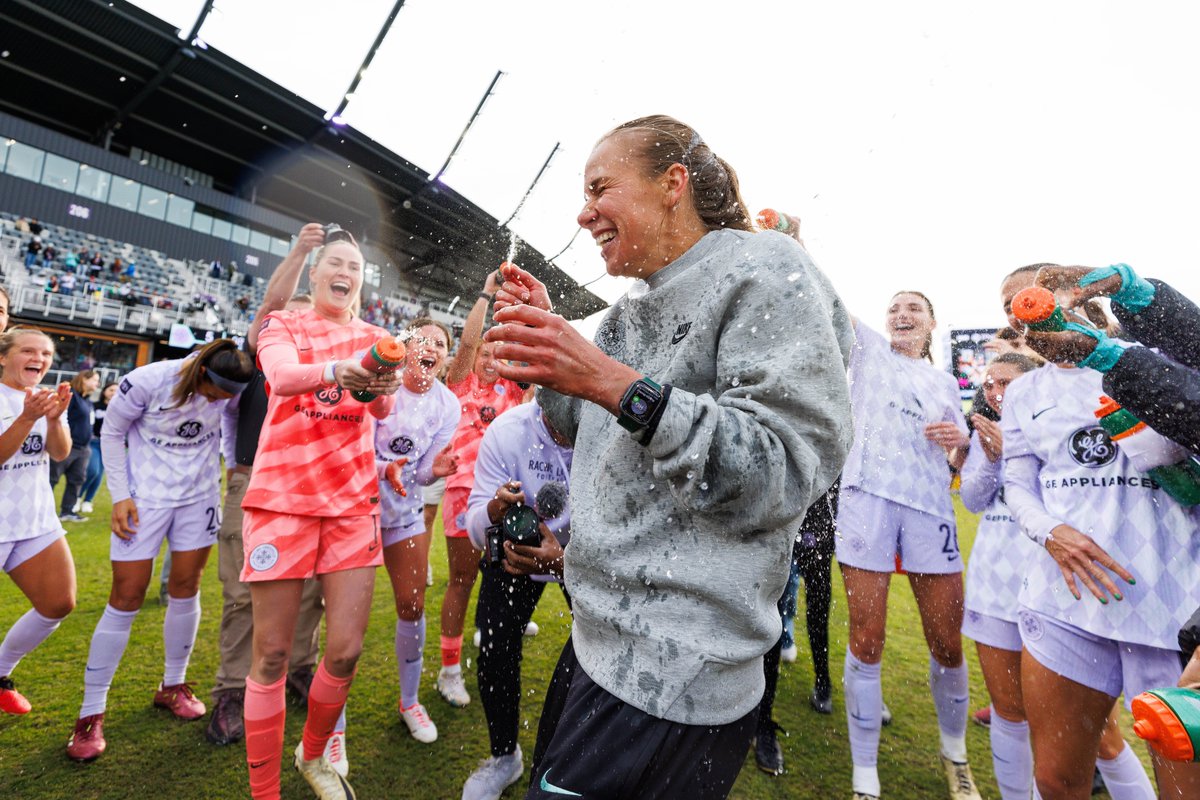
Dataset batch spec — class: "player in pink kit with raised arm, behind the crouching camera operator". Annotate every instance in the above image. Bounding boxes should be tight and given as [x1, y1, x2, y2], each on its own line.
[438, 272, 524, 706]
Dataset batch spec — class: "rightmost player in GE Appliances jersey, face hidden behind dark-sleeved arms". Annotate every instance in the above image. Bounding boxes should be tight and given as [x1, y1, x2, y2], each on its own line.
[1001, 265, 1200, 800]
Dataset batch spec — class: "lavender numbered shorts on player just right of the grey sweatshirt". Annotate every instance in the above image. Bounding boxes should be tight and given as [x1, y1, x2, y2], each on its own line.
[836, 488, 962, 575]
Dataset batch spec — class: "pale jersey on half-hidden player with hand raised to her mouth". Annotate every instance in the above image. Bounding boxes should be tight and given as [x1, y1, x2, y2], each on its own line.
[961, 431, 1052, 622]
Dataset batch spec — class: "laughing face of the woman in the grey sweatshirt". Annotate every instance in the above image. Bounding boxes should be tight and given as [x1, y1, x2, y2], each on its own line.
[577, 132, 673, 278]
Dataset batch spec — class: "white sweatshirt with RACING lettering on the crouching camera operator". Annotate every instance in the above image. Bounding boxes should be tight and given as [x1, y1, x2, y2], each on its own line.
[466, 403, 574, 578]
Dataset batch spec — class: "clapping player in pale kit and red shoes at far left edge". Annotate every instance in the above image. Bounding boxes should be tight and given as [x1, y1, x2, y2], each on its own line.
[0, 327, 76, 714]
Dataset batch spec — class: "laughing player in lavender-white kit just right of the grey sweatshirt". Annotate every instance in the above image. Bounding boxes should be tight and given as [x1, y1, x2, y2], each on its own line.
[836, 291, 979, 800]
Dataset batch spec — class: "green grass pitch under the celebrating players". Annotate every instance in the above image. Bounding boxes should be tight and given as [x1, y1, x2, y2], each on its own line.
[0, 489, 1148, 800]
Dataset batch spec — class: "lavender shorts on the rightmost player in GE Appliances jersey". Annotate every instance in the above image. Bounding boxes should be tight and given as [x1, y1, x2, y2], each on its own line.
[1018, 606, 1183, 708]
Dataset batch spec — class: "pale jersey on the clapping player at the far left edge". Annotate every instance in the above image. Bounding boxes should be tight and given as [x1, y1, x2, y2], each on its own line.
[0, 384, 67, 542]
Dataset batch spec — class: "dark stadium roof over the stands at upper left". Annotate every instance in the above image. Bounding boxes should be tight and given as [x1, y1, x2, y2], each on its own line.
[0, 0, 607, 318]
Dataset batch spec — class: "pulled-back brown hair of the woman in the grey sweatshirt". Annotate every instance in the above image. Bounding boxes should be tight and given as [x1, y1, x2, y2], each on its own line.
[600, 114, 754, 230]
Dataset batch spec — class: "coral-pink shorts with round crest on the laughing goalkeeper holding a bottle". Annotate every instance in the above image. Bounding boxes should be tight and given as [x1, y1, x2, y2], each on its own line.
[241, 509, 383, 582]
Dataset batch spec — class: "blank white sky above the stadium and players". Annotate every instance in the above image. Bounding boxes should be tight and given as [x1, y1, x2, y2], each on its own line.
[137, 0, 1200, 340]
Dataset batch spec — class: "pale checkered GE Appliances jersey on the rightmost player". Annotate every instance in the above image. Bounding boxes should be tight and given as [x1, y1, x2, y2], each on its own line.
[1001, 367, 1200, 650]
